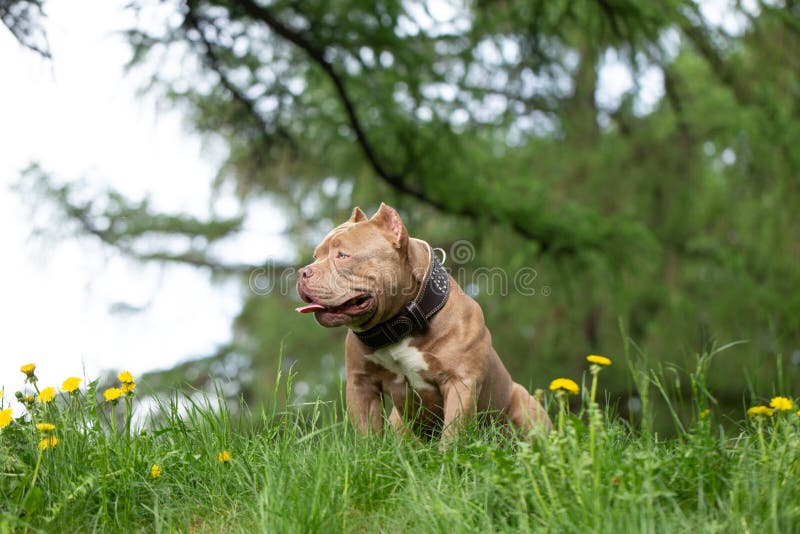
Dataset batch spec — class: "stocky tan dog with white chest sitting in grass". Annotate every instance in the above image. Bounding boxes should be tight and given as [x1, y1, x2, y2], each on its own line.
[297, 204, 552, 440]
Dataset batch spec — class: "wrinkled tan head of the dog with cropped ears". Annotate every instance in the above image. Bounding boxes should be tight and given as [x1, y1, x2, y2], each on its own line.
[297, 206, 408, 328]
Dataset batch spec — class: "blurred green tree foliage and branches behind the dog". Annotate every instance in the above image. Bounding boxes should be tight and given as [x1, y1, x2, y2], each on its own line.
[14, 0, 800, 416]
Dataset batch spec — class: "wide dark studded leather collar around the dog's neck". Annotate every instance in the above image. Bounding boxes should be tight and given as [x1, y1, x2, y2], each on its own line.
[353, 243, 450, 350]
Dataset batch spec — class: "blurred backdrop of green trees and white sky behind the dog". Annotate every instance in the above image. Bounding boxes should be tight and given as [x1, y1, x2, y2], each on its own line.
[0, 0, 800, 428]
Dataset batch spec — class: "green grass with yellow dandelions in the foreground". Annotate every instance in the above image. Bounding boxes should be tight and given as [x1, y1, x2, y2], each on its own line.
[0, 355, 800, 534]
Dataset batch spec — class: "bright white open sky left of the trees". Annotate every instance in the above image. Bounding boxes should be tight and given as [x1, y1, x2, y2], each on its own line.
[0, 0, 288, 400]
